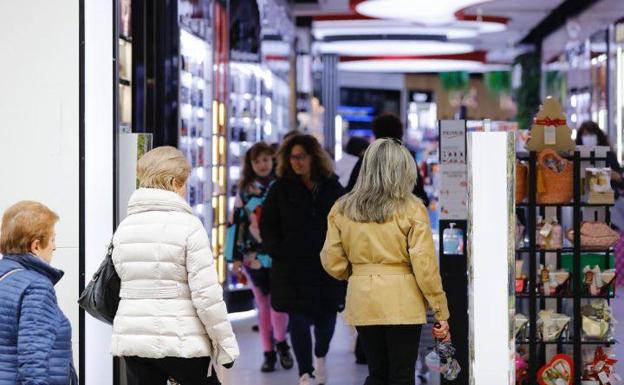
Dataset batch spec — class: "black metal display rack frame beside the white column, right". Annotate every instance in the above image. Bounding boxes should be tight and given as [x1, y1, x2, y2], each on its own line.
[516, 151, 616, 385]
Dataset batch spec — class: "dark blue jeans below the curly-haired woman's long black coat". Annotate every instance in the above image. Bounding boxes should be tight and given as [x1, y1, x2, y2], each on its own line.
[289, 313, 336, 376]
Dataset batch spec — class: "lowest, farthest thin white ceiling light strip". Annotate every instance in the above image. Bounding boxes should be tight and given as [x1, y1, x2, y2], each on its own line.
[338, 59, 509, 73]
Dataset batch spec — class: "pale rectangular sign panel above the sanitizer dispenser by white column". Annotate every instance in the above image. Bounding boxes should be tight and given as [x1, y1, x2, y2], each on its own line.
[440, 120, 468, 220]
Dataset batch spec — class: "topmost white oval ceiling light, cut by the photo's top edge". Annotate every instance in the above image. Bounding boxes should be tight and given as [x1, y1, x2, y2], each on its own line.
[356, 0, 484, 25]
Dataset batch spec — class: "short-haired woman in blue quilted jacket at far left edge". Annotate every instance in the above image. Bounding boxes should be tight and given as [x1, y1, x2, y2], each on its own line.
[0, 201, 78, 385]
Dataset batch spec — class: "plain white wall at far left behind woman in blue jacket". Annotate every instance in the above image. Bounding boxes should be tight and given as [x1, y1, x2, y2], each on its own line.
[0, 0, 79, 366]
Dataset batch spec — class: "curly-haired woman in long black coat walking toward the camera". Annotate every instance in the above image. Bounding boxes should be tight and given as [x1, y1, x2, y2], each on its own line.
[260, 135, 345, 385]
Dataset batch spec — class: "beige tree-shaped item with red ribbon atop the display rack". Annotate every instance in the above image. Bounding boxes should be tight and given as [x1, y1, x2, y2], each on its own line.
[527, 96, 575, 153]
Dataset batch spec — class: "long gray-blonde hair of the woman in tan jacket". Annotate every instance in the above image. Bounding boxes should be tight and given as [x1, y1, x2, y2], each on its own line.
[339, 139, 418, 223]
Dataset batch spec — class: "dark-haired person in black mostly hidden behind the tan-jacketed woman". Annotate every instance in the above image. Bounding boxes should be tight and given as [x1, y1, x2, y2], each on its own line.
[346, 114, 429, 207]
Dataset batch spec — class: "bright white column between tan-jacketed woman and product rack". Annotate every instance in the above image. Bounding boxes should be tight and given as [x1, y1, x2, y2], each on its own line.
[468, 132, 515, 385]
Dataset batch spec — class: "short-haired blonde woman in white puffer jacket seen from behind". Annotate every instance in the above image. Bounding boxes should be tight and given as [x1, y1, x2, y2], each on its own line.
[112, 147, 239, 385]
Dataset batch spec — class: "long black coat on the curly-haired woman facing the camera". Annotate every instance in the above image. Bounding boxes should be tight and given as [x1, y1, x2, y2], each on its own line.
[260, 176, 346, 317]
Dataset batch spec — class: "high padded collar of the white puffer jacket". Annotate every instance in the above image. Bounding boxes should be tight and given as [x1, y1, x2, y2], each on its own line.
[128, 188, 193, 215]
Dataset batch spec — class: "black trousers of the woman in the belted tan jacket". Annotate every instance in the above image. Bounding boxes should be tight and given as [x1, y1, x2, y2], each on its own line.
[357, 325, 422, 385]
